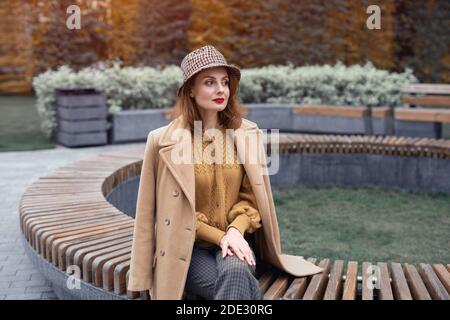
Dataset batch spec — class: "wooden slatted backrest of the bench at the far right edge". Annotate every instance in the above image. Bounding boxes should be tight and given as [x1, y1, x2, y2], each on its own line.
[402, 83, 450, 108]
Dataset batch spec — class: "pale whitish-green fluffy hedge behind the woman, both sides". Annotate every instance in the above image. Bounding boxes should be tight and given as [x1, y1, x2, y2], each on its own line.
[33, 63, 417, 138]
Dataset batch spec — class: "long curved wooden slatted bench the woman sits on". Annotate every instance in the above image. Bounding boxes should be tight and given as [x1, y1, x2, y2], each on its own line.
[20, 134, 450, 300]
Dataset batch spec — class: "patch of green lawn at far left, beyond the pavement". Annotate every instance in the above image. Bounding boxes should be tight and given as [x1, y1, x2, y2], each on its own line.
[0, 96, 55, 152]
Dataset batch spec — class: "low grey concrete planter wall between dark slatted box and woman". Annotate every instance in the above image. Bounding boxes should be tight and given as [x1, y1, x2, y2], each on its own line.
[109, 108, 172, 144]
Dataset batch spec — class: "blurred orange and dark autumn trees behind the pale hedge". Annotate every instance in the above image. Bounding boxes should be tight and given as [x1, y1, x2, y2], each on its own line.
[0, 0, 450, 93]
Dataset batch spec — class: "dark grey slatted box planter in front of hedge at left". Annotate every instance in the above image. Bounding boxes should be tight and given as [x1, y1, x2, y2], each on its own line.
[56, 88, 108, 147]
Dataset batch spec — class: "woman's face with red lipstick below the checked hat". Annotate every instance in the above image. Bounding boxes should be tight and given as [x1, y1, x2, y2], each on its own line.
[191, 67, 230, 112]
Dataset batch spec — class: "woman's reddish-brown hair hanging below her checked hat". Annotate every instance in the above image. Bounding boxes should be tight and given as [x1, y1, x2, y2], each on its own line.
[170, 70, 245, 132]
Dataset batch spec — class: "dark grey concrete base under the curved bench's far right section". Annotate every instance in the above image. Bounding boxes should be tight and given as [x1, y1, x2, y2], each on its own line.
[271, 153, 450, 193]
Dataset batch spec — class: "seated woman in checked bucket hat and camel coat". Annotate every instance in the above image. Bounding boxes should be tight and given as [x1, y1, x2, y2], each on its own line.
[128, 46, 322, 299]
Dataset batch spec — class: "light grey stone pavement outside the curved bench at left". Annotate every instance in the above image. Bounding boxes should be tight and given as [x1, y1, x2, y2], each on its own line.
[0, 143, 143, 300]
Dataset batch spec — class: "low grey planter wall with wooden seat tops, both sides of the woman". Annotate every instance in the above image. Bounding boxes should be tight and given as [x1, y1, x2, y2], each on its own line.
[106, 104, 450, 143]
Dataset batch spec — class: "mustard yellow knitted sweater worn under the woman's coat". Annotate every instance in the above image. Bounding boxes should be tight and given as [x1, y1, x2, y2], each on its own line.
[192, 128, 261, 247]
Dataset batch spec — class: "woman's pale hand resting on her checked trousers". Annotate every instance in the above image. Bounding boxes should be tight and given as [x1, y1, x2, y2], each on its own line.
[220, 228, 256, 266]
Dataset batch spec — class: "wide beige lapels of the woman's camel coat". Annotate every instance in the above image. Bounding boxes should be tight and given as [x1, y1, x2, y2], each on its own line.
[158, 116, 265, 212]
